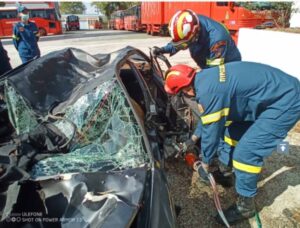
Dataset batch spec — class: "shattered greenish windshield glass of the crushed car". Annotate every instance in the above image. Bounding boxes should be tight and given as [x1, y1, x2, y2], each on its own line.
[7, 79, 148, 178]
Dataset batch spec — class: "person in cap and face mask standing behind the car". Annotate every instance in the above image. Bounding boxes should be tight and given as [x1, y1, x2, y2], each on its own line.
[13, 5, 40, 63]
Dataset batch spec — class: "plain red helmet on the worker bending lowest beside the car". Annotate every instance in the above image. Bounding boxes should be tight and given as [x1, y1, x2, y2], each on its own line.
[165, 64, 196, 95]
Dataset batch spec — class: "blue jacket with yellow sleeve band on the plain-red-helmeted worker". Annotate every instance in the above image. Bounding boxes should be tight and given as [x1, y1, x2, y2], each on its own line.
[194, 62, 300, 163]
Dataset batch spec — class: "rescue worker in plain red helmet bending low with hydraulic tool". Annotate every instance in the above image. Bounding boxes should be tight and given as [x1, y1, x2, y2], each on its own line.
[165, 62, 300, 224]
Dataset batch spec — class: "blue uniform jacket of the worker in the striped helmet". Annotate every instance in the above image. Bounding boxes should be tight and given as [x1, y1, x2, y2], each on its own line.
[162, 15, 241, 69]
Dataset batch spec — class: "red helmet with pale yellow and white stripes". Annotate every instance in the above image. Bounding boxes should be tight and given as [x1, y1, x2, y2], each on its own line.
[169, 10, 200, 49]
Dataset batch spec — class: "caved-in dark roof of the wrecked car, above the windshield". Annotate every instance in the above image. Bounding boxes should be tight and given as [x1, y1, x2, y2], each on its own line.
[0, 46, 142, 115]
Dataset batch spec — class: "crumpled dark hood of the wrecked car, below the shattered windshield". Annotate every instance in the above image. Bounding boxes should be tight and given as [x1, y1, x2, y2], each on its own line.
[4, 167, 148, 228]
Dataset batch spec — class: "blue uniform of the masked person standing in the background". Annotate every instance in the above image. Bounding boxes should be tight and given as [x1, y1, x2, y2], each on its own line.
[13, 22, 40, 58]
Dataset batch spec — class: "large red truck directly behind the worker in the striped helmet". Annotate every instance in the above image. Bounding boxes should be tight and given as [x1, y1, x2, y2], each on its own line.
[141, 2, 270, 41]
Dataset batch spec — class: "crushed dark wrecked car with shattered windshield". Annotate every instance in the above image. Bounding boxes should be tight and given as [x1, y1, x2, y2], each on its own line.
[0, 47, 193, 227]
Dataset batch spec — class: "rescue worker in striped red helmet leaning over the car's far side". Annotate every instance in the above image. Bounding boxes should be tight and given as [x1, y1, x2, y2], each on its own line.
[152, 10, 241, 69]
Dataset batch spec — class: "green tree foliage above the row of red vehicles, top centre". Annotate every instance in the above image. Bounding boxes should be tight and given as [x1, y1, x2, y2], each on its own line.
[91, 2, 140, 19]
